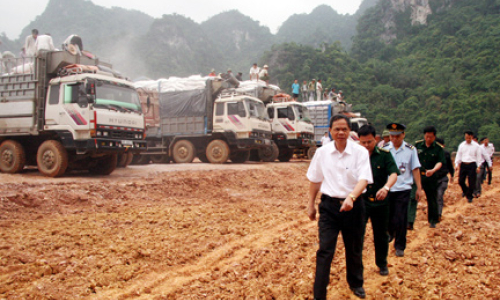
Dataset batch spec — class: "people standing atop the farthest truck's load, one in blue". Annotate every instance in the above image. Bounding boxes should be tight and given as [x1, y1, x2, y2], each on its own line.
[292, 79, 344, 102]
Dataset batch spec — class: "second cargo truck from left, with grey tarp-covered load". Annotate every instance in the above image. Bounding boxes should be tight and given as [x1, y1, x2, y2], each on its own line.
[133, 78, 271, 164]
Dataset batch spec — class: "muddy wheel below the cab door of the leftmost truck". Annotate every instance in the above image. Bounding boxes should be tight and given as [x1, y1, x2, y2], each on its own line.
[36, 140, 68, 177]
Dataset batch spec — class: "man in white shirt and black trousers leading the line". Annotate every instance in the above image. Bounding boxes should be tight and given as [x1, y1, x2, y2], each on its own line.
[307, 115, 373, 299]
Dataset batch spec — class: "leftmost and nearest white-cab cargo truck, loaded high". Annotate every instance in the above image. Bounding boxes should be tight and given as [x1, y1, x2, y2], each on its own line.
[0, 51, 146, 177]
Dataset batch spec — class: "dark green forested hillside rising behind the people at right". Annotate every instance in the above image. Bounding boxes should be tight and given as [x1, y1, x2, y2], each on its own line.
[274, 0, 500, 147]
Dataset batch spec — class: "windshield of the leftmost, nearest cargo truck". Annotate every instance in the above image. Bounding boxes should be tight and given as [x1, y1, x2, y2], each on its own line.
[95, 82, 142, 112]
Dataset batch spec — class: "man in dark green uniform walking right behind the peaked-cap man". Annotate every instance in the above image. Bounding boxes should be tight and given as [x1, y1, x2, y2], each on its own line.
[408, 126, 446, 228]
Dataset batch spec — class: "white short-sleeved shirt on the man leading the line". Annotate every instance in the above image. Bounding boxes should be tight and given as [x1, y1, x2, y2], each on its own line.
[307, 140, 373, 199]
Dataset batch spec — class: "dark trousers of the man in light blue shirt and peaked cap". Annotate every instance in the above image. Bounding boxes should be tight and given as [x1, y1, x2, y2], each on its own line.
[388, 190, 411, 251]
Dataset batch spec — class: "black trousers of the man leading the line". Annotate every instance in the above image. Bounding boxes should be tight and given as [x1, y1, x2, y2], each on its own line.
[314, 195, 365, 299]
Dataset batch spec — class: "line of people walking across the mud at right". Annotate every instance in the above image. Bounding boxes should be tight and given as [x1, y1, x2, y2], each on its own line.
[307, 115, 494, 299]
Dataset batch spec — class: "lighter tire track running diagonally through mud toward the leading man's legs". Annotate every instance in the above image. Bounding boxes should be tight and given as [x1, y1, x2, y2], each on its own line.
[92, 218, 316, 299]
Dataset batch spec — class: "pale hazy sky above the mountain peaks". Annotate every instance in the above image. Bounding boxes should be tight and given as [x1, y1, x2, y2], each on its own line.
[0, 0, 362, 39]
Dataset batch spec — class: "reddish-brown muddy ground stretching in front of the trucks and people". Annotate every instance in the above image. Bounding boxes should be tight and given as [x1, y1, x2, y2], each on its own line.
[0, 160, 500, 299]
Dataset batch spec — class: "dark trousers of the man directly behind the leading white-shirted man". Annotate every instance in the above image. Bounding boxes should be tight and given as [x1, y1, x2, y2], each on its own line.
[365, 203, 389, 268]
